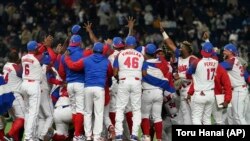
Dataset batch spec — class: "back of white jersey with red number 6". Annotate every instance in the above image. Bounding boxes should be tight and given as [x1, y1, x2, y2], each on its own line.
[22, 54, 42, 81]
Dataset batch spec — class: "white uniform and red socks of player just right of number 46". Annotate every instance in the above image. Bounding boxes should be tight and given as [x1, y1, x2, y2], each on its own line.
[141, 59, 166, 139]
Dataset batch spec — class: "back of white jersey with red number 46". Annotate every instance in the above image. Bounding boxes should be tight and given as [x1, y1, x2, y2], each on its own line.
[118, 49, 144, 79]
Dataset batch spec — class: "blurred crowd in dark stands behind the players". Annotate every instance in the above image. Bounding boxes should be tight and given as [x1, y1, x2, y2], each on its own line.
[0, 0, 250, 70]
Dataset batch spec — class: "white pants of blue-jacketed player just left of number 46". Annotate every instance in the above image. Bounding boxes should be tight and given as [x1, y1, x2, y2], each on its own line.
[84, 87, 105, 140]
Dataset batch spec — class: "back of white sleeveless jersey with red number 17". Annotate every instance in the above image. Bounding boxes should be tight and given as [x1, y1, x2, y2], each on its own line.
[193, 58, 218, 91]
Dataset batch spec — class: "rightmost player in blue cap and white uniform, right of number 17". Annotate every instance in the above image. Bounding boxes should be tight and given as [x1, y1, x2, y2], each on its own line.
[221, 44, 248, 125]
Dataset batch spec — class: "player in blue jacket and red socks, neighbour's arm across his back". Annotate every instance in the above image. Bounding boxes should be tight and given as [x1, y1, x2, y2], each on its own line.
[58, 35, 85, 141]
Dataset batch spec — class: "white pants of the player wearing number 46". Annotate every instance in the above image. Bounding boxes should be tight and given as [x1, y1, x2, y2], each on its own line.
[115, 78, 142, 136]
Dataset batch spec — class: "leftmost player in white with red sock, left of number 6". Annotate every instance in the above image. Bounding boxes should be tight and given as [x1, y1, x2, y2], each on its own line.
[3, 52, 26, 141]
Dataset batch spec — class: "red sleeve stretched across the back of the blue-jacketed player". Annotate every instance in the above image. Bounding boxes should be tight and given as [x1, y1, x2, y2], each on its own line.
[65, 56, 84, 71]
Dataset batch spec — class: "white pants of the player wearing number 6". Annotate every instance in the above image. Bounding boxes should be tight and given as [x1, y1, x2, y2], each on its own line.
[22, 80, 41, 140]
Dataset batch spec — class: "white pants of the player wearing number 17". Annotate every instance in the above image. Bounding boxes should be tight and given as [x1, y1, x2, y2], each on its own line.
[191, 90, 215, 125]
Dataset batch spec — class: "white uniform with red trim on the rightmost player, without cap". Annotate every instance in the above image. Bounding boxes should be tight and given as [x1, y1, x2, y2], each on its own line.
[223, 57, 248, 125]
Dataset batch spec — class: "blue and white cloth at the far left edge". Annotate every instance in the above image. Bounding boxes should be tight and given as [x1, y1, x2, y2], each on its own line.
[0, 75, 15, 115]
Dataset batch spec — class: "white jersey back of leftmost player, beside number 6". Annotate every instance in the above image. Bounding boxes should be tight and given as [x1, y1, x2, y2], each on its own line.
[3, 62, 22, 92]
